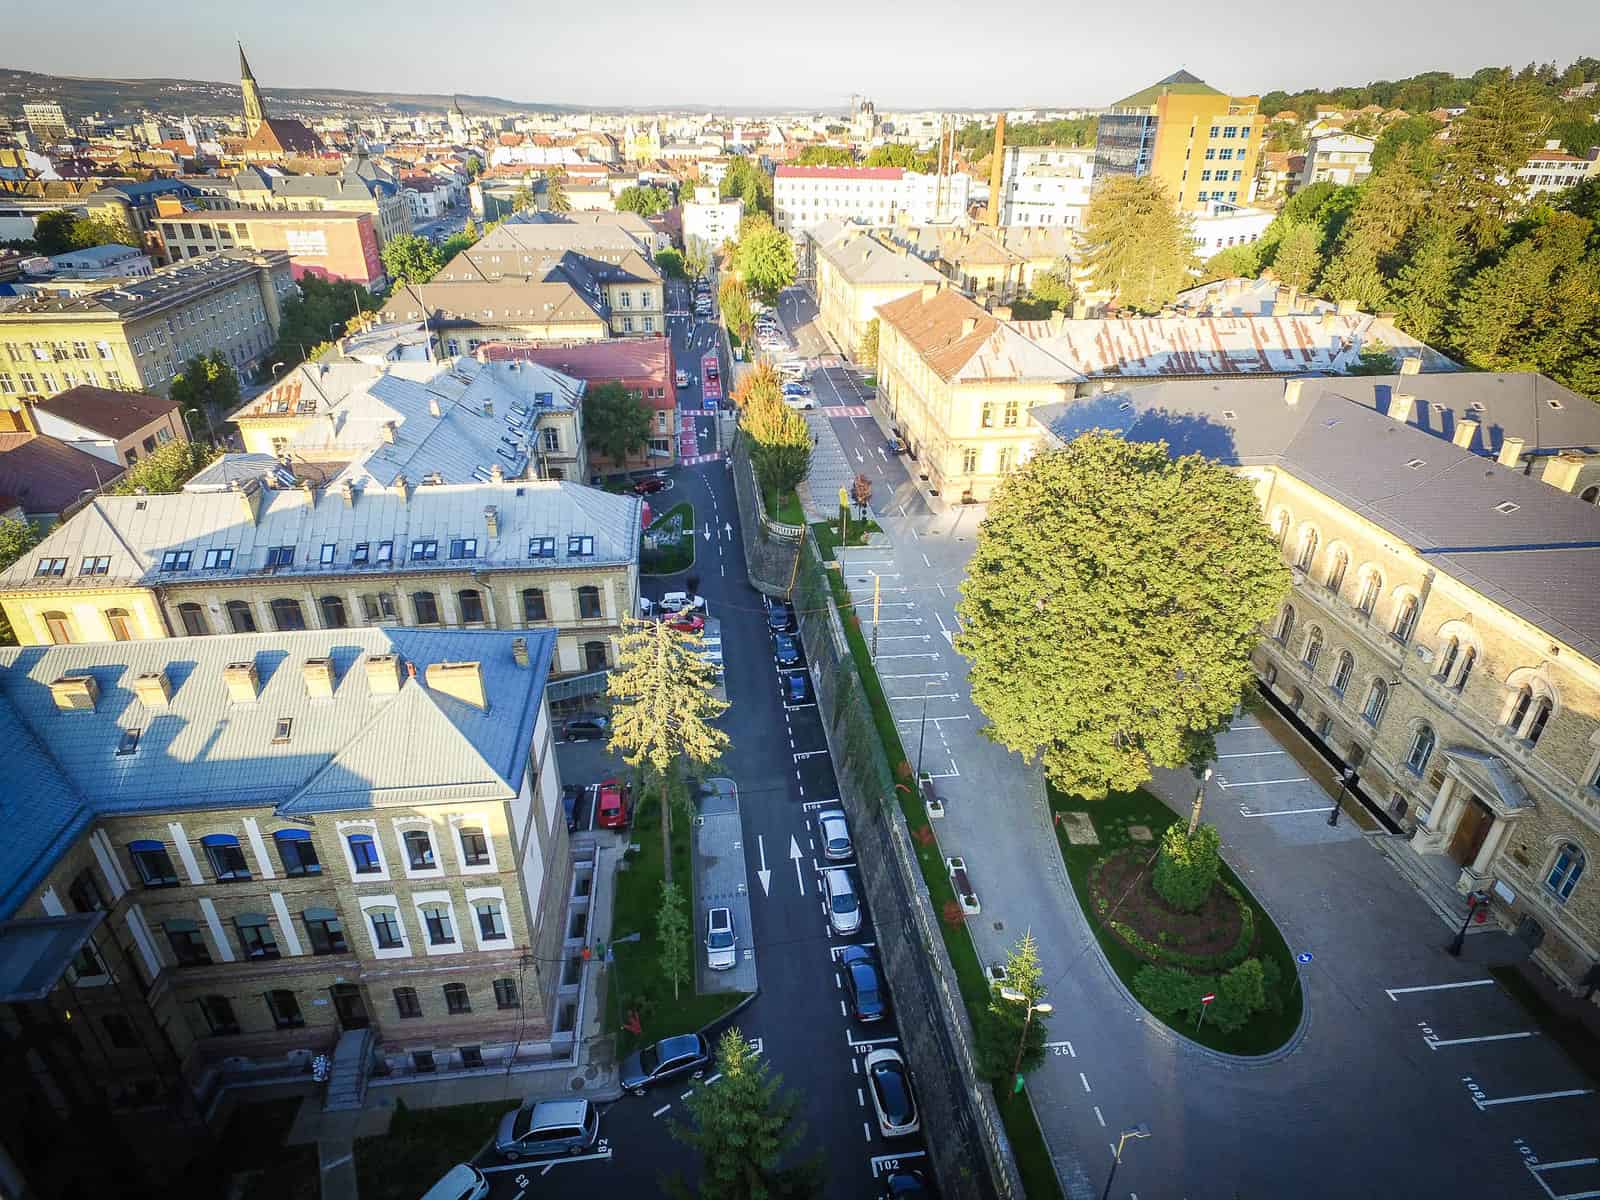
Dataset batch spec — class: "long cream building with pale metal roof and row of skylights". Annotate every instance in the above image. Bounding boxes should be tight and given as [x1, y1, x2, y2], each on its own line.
[0, 483, 642, 675]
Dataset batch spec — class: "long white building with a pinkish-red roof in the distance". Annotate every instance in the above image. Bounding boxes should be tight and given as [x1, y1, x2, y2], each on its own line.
[773, 166, 973, 237]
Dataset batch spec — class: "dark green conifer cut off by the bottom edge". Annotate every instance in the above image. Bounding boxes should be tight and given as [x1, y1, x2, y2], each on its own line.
[667, 1027, 822, 1200]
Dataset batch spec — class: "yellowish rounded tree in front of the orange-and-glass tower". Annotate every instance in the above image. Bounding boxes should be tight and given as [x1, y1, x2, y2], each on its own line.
[1083, 176, 1195, 312]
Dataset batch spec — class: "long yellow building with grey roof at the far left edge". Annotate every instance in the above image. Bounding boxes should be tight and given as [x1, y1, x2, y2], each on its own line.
[0, 250, 296, 397]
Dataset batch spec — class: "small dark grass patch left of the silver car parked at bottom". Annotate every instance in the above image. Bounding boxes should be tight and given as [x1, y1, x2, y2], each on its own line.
[356, 1101, 515, 1200]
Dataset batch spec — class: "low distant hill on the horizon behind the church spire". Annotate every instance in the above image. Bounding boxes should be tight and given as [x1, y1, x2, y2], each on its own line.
[0, 67, 579, 118]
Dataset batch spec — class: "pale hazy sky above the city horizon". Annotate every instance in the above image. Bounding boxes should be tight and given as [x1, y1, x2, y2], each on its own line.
[0, 0, 1600, 110]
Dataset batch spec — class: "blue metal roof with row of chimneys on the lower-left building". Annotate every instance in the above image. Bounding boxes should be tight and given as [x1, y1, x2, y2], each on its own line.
[0, 627, 555, 918]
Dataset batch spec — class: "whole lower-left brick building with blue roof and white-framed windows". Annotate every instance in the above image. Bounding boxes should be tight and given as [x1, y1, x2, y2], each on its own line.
[0, 629, 594, 1190]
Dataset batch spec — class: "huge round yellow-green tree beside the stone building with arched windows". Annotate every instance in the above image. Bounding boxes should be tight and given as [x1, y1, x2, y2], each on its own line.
[955, 432, 1290, 797]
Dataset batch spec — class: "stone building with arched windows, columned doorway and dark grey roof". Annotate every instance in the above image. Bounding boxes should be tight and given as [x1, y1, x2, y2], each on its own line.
[1037, 374, 1600, 989]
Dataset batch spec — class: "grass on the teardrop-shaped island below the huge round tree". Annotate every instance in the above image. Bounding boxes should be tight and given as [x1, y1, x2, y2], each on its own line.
[1050, 787, 1301, 1054]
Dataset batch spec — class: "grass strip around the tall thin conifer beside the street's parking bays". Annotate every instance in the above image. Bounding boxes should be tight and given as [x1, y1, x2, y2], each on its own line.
[606, 795, 744, 1056]
